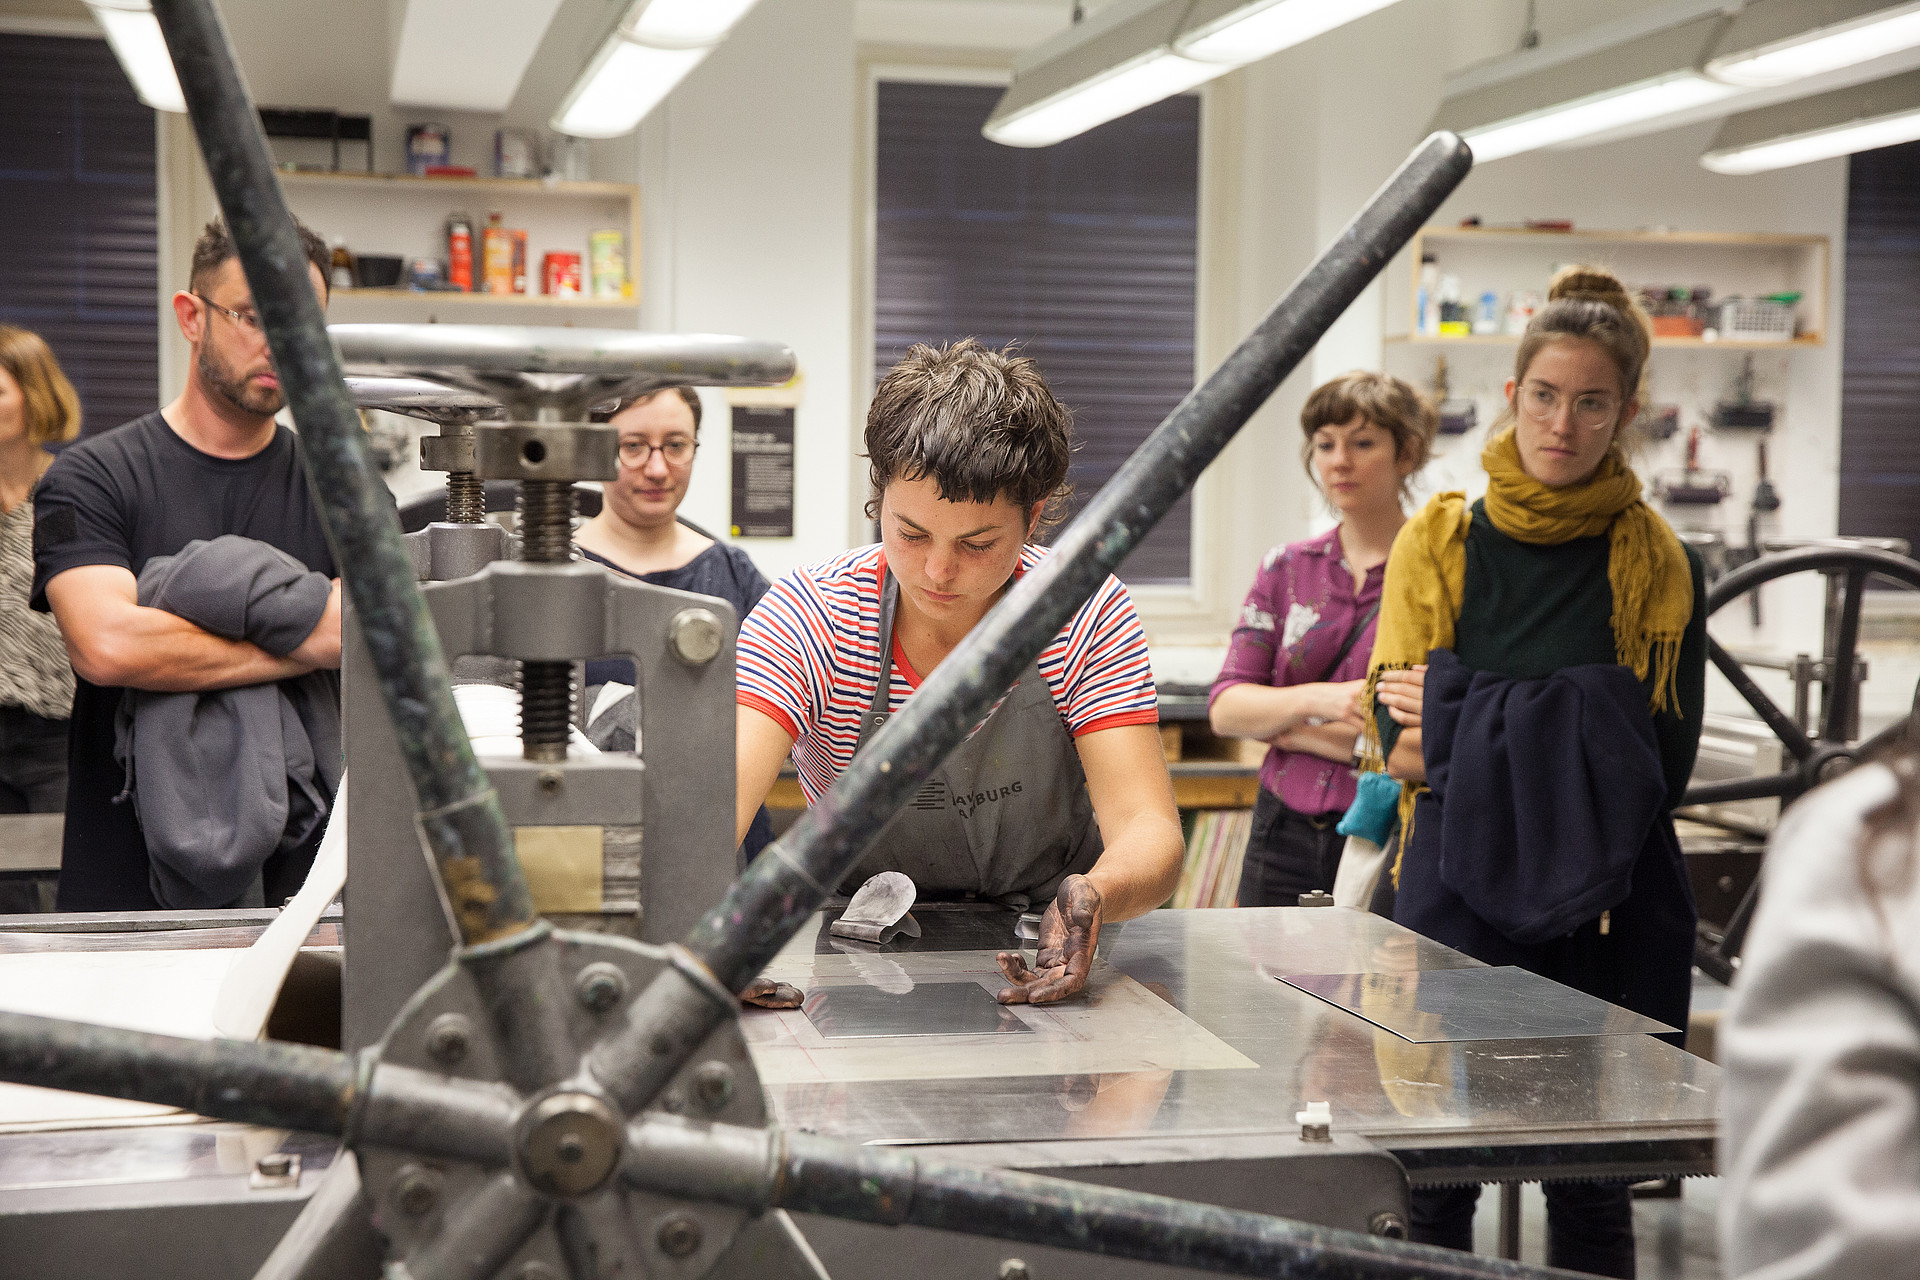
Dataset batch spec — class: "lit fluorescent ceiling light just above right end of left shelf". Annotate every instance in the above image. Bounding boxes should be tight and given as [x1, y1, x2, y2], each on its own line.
[551, 0, 755, 138]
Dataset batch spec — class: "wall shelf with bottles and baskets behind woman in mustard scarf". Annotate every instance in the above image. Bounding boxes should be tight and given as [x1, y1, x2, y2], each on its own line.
[1388, 226, 1830, 351]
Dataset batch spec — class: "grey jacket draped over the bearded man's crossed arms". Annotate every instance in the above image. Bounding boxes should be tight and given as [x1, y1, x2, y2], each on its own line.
[113, 533, 342, 910]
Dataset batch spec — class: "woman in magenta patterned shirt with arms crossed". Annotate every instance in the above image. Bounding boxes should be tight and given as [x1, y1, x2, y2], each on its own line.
[1208, 372, 1440, 906]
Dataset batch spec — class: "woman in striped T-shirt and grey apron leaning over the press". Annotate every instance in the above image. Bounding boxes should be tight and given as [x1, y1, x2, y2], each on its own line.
[735, 340, 1183, 1004]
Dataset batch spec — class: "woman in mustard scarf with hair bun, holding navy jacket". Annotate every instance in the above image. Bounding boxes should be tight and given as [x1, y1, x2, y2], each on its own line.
[1363, 267, 1707, 1276]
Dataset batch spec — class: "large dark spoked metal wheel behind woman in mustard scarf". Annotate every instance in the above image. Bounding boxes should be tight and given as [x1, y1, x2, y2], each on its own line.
[1682, 547, 1920, 983]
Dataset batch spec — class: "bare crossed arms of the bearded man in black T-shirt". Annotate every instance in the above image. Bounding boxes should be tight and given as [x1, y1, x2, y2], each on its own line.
[46, 564, 340, 693]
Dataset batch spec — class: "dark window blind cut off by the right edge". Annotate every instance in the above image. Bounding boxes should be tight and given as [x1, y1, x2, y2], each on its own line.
[1839, 142, 1920, 551]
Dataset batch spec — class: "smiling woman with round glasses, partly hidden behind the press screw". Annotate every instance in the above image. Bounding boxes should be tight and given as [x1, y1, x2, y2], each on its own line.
[574, 388, 774, 860]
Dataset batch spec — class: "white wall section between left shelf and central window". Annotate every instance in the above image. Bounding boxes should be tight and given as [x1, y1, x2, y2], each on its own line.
[637, 0, 866, 578]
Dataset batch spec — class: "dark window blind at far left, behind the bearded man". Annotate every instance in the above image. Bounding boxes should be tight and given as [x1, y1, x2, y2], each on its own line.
[0, 33, 159, 434]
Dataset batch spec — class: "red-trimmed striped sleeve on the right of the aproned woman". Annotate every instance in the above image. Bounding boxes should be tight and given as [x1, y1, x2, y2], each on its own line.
[1041, 556, 1160, 737]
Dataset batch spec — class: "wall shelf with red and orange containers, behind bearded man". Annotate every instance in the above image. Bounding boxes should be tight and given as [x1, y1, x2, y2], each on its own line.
[280, 173, 639, 328]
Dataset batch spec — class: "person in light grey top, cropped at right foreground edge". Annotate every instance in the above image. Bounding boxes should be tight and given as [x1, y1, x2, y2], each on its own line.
[1718, 743, 1920, 1280]
